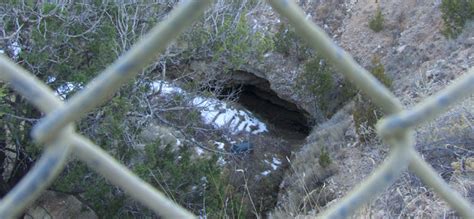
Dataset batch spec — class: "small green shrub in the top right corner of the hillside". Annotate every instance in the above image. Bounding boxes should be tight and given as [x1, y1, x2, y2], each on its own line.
[440, 0, 474, 38]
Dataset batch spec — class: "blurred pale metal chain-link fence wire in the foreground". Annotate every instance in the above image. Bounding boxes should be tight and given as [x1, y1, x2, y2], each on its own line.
[0, 0, 474, 218]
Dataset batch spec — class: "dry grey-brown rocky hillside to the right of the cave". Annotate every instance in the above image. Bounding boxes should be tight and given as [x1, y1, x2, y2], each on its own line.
[268, 0, 474, 218]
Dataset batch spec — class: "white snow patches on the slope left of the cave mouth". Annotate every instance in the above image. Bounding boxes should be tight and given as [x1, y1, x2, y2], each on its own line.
[150, 81, 268, 134]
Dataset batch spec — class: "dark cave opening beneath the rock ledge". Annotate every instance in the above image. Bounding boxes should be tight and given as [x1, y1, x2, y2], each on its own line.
[224, 71, 312, 140]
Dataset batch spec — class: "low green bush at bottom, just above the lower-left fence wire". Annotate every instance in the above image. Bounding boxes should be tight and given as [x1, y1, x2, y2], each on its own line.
[134, 141, 244, 218]
